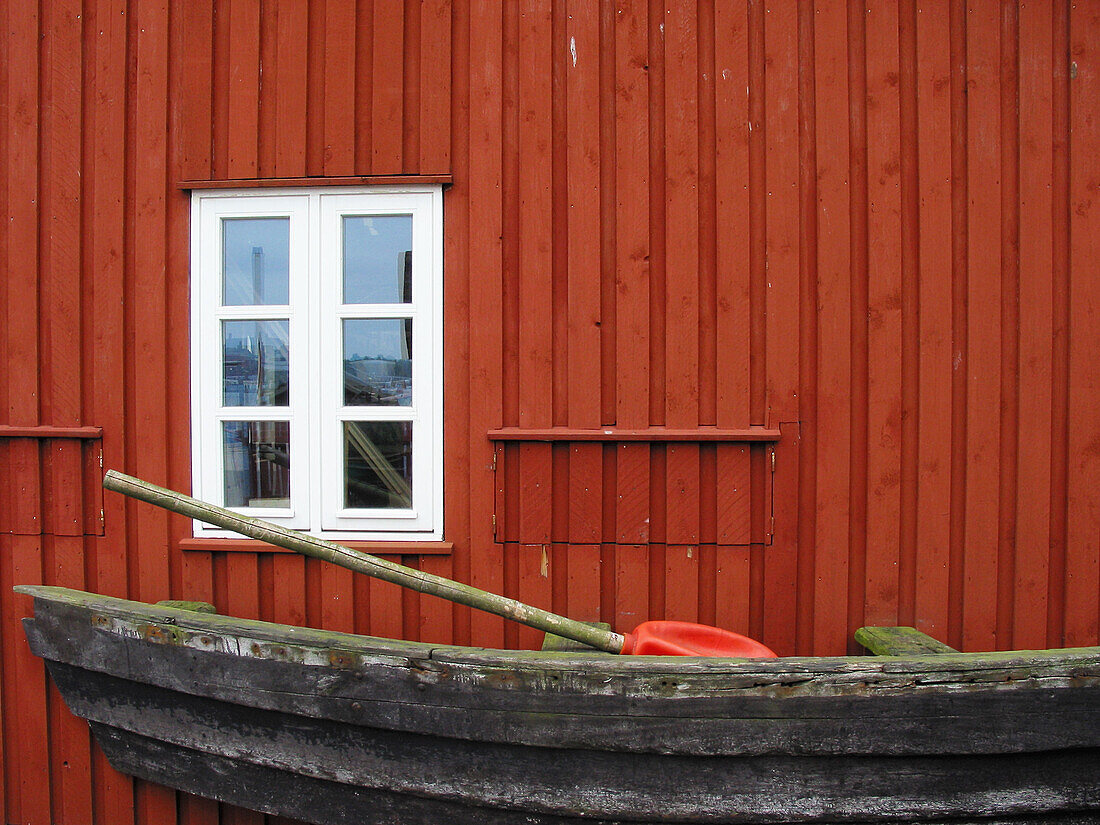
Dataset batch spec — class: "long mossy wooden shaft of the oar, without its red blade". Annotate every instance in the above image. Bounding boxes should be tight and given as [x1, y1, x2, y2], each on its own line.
[103, 470, 625, 653]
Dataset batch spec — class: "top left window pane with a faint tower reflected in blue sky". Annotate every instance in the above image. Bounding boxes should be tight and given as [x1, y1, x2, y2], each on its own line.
[221, 218, 290, 307]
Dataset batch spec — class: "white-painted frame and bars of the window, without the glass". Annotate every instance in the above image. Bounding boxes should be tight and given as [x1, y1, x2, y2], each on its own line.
[190, 184, 443, 541]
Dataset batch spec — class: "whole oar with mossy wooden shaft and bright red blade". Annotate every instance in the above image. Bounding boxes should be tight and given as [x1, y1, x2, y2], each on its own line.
[103, 470, 776, 658]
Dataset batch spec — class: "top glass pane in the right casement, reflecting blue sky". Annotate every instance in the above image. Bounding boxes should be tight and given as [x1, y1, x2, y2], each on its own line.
[343, 215, 413, 304]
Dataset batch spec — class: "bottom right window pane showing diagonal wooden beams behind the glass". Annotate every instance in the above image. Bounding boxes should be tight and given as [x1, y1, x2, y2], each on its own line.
[344, 421, 413, 509]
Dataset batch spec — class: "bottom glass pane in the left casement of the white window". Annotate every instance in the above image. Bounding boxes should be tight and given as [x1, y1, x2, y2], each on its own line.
[222, 421, 290, 508]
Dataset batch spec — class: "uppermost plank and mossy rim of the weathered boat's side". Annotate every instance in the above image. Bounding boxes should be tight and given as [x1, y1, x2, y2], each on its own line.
[21, 587, 1100, 757]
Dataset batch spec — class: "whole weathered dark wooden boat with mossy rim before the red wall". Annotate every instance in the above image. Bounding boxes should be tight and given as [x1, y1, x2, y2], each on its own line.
[19, 586, 1100, 825]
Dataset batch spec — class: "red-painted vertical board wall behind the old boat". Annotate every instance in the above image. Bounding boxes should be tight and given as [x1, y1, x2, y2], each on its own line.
[0, 0, 1100, 825]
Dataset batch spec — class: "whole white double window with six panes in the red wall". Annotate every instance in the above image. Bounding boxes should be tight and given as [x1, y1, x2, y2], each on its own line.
[191, 186, 443, 539]
